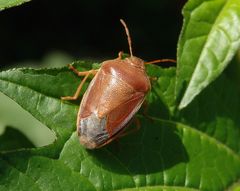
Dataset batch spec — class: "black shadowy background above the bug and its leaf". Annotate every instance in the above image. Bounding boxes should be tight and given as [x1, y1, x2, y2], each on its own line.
[0, 0, 185, 69]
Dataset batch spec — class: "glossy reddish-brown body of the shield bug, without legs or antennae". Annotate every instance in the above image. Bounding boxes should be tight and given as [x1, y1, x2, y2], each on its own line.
[77, 56, 151, 149]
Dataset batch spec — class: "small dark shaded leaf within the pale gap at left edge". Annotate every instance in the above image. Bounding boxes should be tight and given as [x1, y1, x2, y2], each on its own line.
[0, 127, 34, 151]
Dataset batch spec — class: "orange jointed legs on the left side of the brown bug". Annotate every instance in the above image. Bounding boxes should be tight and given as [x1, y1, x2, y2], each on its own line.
[61, 65, 98, 100]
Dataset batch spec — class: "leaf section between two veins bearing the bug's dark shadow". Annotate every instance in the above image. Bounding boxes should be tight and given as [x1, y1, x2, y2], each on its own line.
[60, 119, 240, 190]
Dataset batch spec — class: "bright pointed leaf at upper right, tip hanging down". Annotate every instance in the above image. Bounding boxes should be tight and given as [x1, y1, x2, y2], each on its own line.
[176, 0, 240, 109]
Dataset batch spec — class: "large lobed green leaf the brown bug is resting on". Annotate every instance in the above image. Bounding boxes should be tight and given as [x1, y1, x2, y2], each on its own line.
[0, 62, 240, 191]
